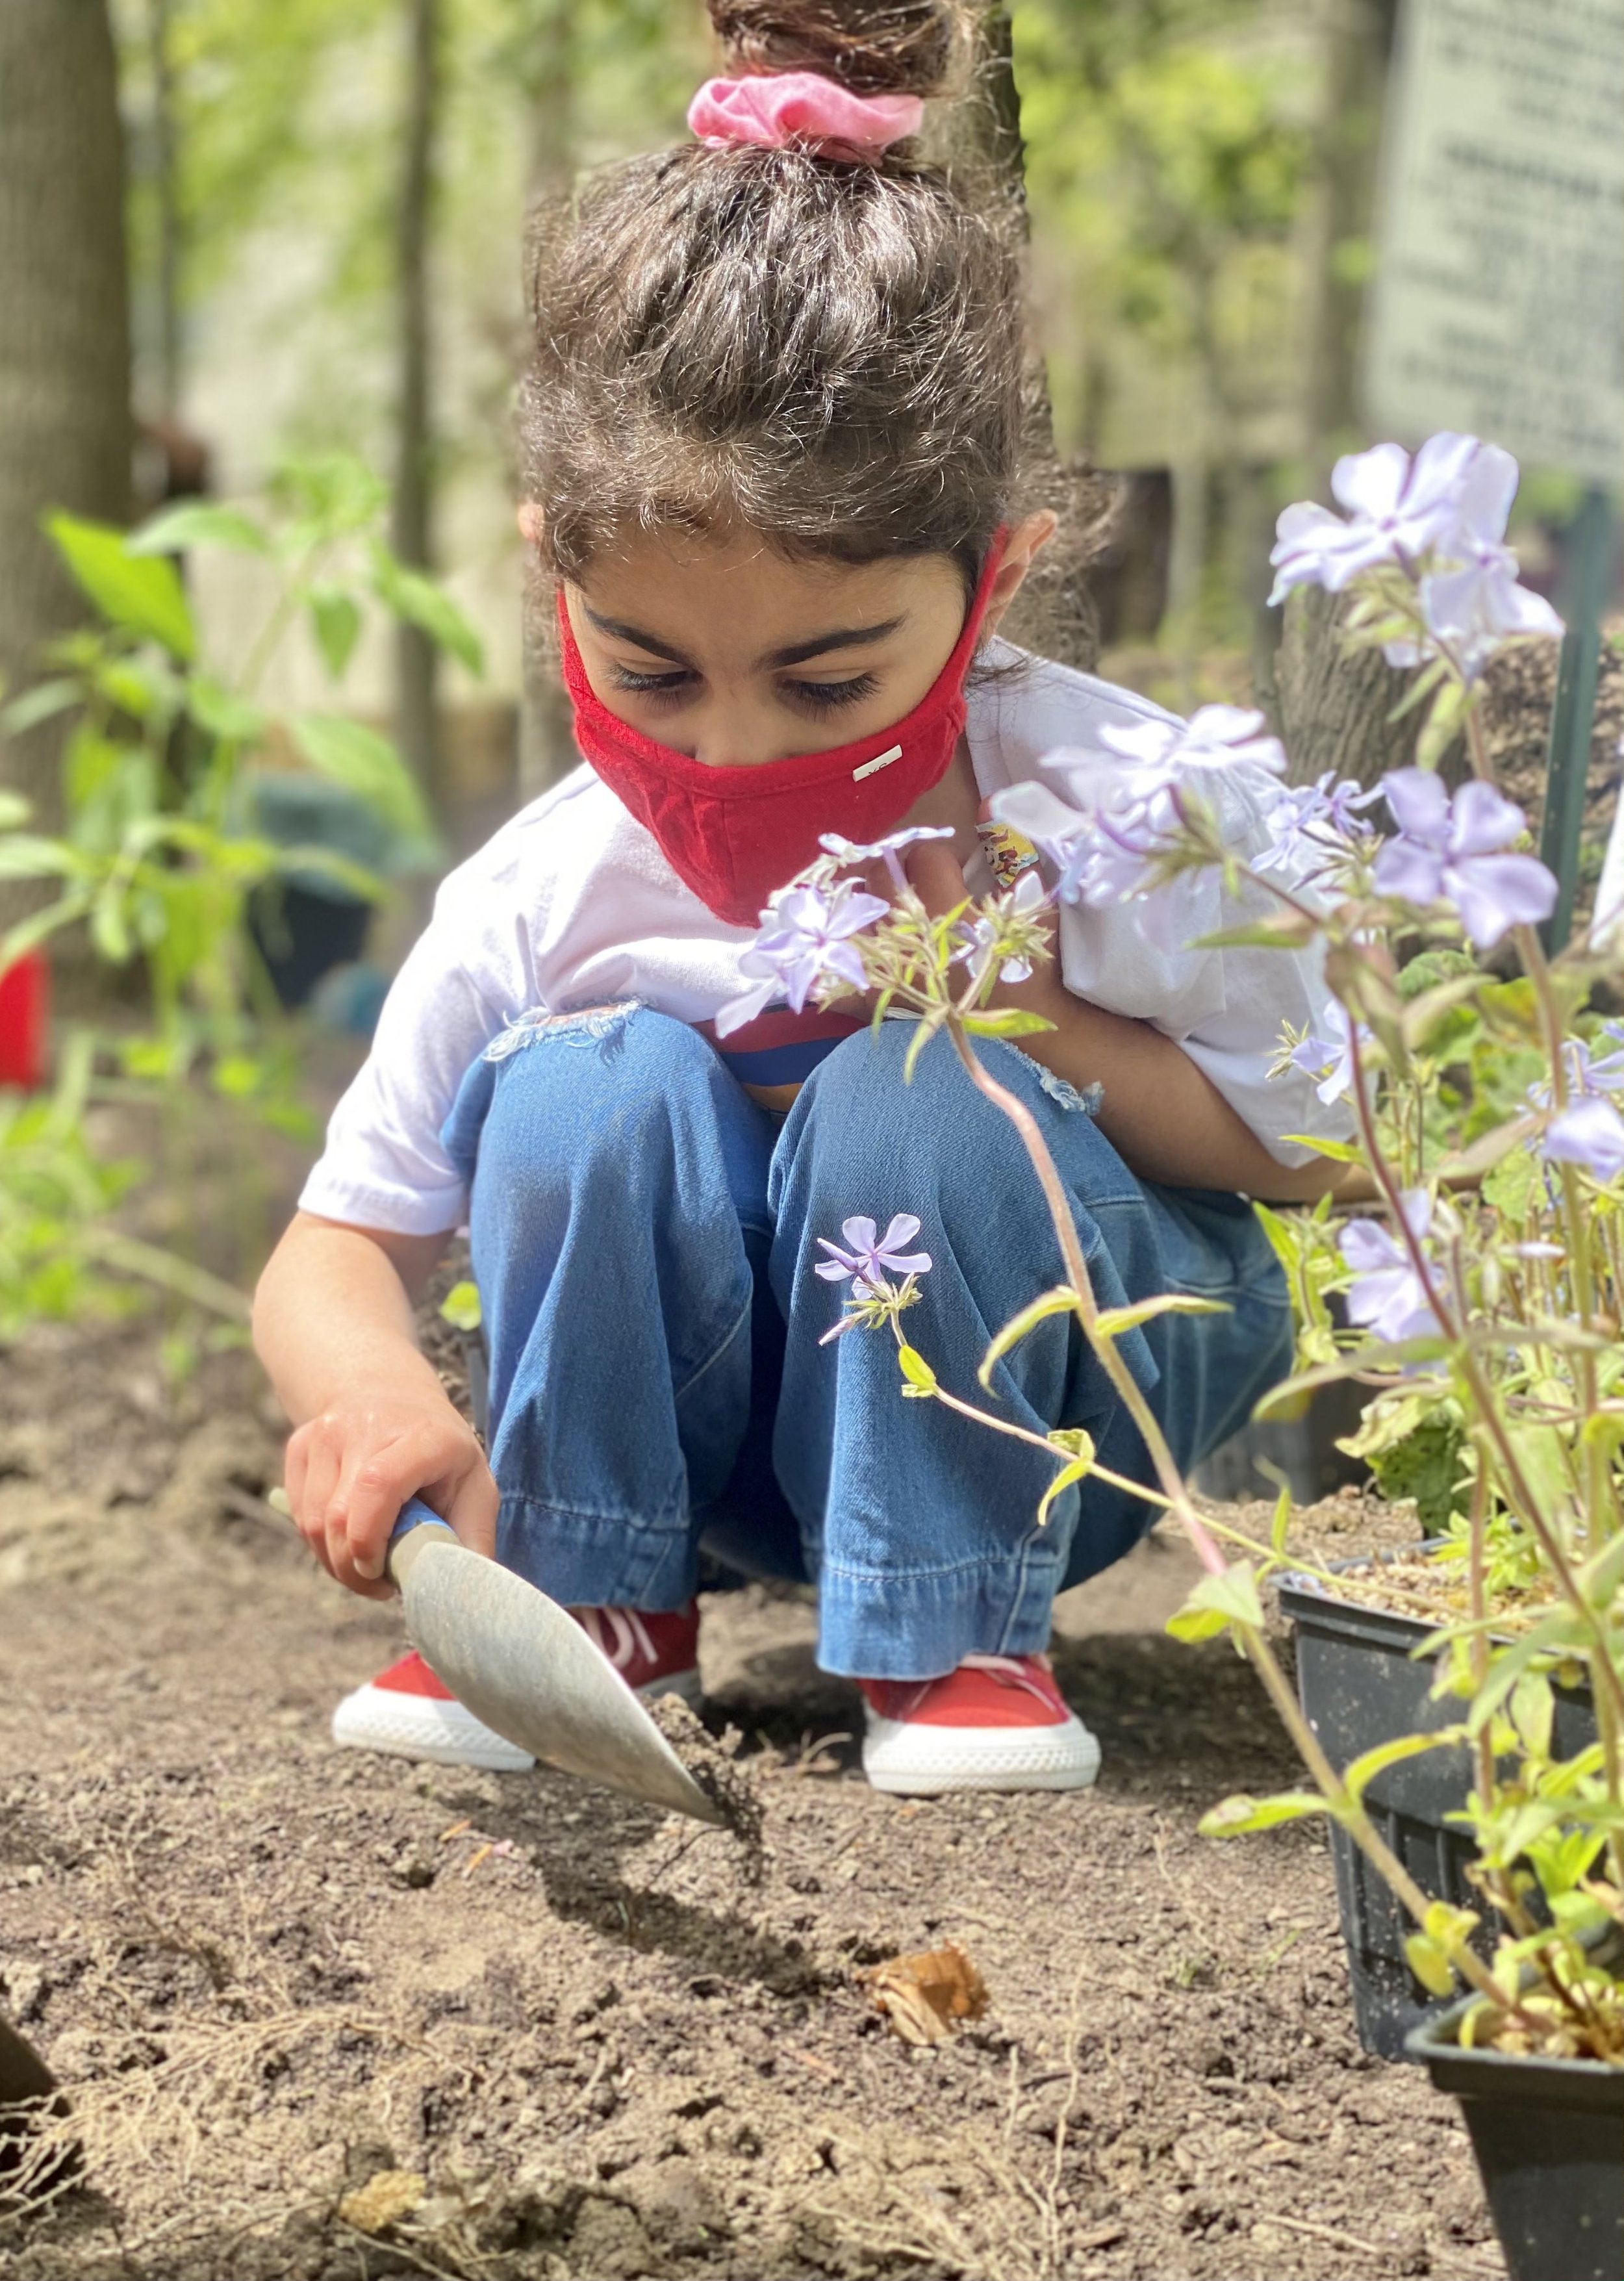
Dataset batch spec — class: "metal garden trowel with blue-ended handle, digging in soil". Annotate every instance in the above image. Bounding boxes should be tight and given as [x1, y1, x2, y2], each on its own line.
[390, 1496, 723, 1822]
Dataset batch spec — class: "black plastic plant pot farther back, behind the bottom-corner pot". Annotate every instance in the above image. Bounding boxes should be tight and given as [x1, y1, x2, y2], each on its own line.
[1280, 1570, 1596, 2061]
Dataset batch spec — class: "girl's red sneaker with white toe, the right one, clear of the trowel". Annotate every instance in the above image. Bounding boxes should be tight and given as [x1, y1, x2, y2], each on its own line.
[857, 1656, 1099, 1798]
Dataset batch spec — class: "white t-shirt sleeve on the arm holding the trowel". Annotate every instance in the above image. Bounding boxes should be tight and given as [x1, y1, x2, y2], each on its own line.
[299, 874, 529, 1236]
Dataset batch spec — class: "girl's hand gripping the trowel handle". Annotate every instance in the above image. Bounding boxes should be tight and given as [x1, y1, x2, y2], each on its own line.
[285, 1392, 500, 1599]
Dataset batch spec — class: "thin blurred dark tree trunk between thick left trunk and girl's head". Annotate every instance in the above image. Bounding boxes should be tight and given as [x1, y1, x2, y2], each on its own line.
[390, 0, 445, 808]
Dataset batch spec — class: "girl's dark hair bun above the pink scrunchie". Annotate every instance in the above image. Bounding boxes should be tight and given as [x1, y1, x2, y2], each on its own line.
[707, 0, 969, 96]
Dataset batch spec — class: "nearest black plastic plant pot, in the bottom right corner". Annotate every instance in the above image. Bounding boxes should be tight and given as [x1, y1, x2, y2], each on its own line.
[1405, 1998, 1624, 2281]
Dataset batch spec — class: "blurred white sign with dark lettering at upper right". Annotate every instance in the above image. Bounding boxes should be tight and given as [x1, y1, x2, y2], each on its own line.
[1364, 0, 1624, 483]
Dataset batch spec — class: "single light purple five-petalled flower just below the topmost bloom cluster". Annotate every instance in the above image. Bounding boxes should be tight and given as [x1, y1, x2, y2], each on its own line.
[1373, 769, 1556, 951]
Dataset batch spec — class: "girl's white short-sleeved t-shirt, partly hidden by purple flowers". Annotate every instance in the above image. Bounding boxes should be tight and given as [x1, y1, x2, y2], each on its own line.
[299, 641, 1351, 1236]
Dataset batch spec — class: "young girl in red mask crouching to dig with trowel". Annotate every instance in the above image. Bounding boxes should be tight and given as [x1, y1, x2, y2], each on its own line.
[255, 0, 1341, 1790]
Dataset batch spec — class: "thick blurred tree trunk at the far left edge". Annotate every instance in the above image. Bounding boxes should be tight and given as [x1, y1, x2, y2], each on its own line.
[0, 0, 130, 926]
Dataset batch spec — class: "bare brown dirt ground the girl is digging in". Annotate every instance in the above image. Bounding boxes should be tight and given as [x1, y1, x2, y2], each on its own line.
[0, 1330, 1503, 2281]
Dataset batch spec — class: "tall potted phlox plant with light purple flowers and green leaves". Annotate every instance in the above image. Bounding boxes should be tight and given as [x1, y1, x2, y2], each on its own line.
[718, 436, 1624, 2064]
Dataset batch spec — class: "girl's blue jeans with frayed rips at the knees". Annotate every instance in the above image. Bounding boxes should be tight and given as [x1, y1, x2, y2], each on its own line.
[445, 1006, 1291, 1679]
